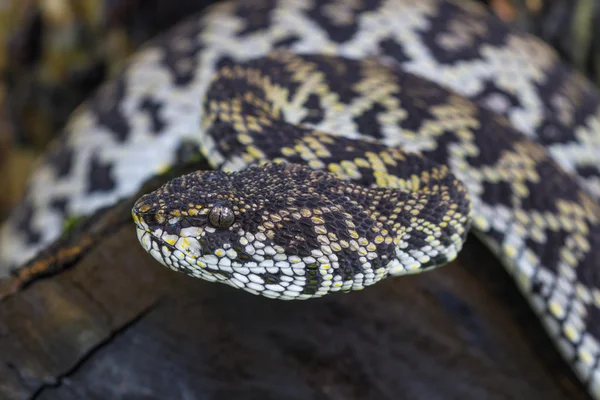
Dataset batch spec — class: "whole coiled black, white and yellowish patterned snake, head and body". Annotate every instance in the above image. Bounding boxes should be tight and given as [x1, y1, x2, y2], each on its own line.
[0, 0, 600, 399]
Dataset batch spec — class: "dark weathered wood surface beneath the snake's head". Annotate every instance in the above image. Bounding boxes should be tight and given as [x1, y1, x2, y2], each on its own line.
[0, 166, 587, 400]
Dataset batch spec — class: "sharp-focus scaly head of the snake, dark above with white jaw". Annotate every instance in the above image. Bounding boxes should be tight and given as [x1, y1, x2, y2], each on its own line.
[132, 164, 468, 299]
